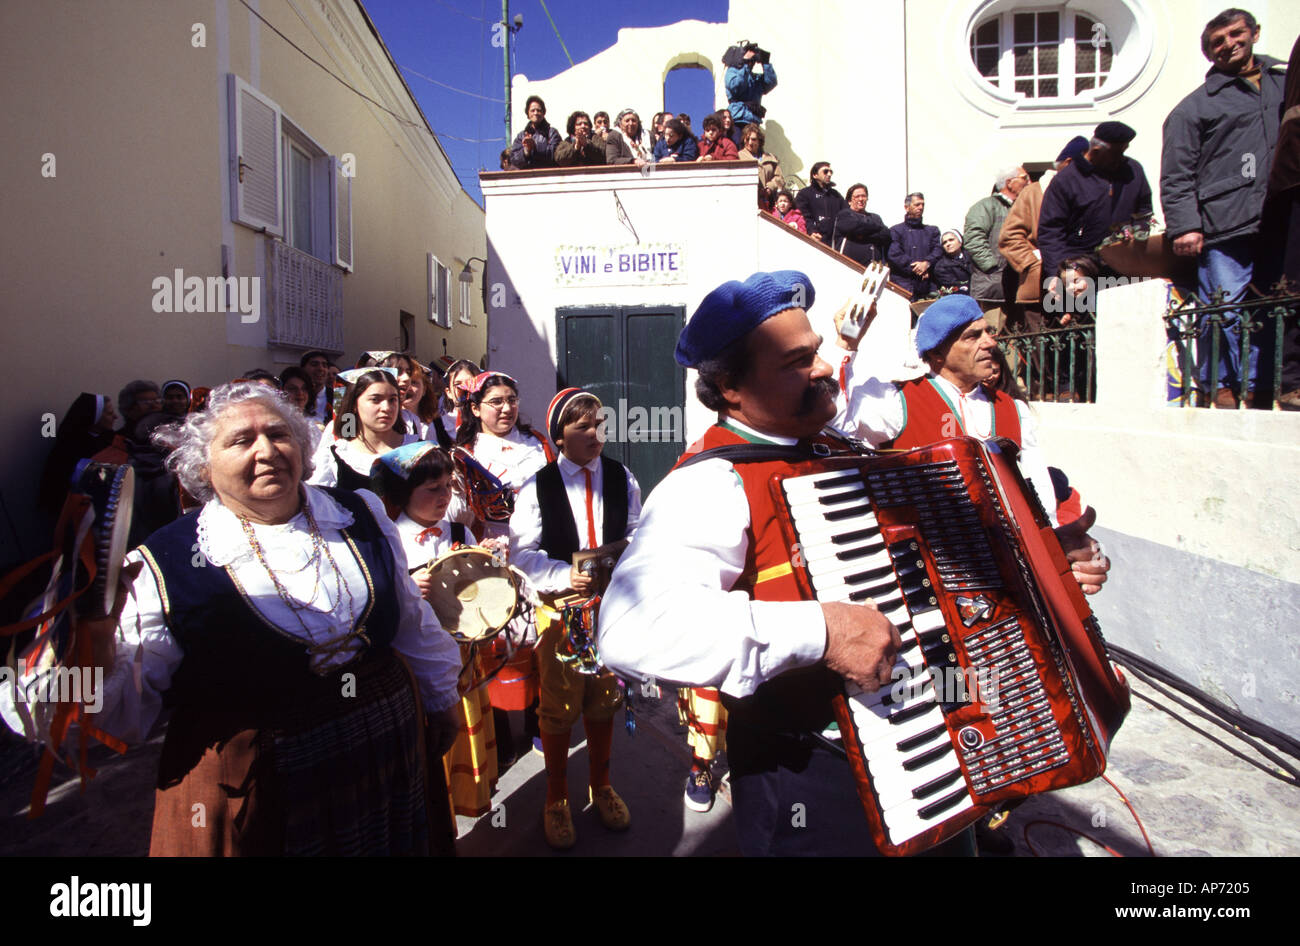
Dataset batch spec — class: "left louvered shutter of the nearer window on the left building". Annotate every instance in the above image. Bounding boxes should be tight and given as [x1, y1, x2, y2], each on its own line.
[229, 73, 285, 237]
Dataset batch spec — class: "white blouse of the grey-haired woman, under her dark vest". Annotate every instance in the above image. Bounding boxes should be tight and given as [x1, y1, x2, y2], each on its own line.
[94, 486, 460, 742]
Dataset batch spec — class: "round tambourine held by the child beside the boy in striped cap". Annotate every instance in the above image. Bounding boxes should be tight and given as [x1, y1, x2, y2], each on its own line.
[429, 548, 523, 643]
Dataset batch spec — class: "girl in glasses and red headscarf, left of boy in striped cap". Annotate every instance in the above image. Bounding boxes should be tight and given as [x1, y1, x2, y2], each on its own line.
[456, 372, 555, 764]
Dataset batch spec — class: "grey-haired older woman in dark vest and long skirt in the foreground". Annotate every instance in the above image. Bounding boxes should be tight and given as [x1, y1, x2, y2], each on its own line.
[91, 382, 460, 855]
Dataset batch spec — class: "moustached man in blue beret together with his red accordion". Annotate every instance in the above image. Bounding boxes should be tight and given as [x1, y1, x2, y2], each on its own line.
[599, 273, 1127, 855]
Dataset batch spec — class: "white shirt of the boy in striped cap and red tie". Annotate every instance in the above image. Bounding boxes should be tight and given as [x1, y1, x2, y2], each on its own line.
[510, 455, 641, 594]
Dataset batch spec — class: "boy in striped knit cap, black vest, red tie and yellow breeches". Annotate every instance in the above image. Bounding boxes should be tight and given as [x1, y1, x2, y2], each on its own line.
[510, 387, 641, 849]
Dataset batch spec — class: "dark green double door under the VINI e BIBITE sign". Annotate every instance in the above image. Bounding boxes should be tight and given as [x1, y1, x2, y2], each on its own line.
[555, 305, 686, 494]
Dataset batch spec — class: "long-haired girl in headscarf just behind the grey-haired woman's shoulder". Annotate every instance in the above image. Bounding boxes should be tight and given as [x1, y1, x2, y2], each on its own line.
[308, 368, 420, 491]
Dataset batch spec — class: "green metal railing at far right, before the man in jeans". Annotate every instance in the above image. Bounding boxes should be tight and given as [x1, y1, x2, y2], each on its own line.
[1165, 285, 1300, 408]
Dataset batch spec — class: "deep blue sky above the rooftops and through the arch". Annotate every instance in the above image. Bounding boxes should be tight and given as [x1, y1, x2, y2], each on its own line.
[361, 0, 728, 203]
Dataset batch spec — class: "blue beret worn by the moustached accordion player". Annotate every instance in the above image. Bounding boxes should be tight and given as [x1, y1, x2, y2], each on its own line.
[676, 269, 814, 368]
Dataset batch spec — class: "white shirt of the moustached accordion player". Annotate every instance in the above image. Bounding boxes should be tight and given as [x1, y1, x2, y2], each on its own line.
[599, 420, 826, 697]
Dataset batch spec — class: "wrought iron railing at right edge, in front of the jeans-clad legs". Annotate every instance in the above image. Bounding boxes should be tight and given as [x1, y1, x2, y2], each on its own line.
[1165, 285, 1300, 407]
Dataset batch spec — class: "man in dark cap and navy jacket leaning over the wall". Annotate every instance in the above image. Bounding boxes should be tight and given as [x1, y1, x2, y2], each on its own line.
[1039, 121, 1152, 292]
